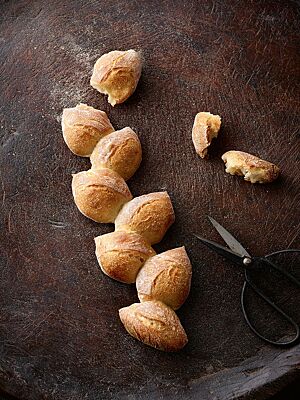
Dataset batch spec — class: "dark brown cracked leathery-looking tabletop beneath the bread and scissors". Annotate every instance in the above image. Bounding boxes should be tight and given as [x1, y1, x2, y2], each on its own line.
[0, 0, 300, 400]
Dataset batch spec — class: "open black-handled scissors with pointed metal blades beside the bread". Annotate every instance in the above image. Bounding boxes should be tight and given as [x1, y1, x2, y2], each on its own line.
[194, 216, 300, 347]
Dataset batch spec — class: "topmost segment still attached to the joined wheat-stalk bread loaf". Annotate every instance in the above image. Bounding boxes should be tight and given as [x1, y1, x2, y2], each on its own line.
[61, 104, 114, 157]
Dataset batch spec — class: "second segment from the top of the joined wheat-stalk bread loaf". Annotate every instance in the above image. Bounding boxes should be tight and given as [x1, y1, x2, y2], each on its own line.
[91, 127, 142, 180]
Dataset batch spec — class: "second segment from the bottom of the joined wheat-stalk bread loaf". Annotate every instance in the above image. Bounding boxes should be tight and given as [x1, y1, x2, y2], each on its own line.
[136, 247, 192, 310]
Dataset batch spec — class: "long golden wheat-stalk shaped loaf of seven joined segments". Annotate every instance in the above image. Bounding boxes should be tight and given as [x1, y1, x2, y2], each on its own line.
[62, 104, 192, 351]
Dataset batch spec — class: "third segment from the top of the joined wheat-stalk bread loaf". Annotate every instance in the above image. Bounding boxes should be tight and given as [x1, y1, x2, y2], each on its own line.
[72, 168, 132, 223]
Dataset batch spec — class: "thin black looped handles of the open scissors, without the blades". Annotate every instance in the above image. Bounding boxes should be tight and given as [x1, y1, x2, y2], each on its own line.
[241, 252, 300, 347]
